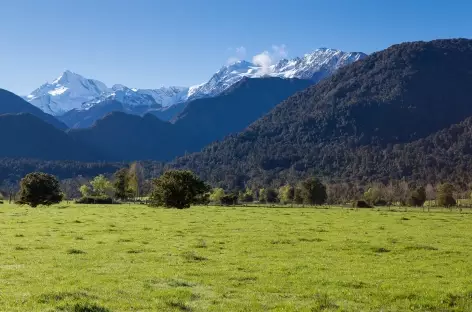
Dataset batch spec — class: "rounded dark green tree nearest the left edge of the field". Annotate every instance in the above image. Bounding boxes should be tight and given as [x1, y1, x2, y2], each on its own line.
[18, 172, 62, 207]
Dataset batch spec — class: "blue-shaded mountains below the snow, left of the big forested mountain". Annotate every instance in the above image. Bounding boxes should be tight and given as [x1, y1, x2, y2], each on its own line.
[0, 77, 312, 161]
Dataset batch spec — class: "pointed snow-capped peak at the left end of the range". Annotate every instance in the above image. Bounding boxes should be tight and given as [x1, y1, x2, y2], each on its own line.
[25, 70, 108, 116]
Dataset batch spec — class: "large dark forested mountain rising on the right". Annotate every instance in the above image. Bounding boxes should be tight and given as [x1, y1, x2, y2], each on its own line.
[173, 39, 472, 187]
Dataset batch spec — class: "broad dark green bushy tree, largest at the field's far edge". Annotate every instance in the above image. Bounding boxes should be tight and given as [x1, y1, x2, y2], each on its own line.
[149, 170, 210, 209]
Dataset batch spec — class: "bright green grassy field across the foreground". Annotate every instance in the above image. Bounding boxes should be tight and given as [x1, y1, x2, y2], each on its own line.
[0, 204, 472, 312]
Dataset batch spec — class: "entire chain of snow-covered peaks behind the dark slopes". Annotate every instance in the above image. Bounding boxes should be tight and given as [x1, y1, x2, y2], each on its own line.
[24, 48, 366, 128]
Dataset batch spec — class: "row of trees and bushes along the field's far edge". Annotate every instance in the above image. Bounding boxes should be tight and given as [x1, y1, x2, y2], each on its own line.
[4, 163, 464, 208]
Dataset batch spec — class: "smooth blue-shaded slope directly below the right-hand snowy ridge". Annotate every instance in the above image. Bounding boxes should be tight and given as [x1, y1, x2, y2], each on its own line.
[174, 77, 312, 152]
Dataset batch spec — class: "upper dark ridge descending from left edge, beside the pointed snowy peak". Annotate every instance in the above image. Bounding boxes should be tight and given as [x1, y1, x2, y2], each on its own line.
[0, 89, 67, 130]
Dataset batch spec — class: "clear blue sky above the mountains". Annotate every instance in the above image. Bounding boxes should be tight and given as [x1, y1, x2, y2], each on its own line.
[0, 0, 472, 94]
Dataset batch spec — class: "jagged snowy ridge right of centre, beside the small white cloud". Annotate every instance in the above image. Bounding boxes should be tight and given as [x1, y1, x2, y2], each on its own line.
[188, 48, 367, 99]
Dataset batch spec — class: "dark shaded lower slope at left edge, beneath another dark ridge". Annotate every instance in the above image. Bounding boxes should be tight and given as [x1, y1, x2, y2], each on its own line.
[0, 114, 98, 160]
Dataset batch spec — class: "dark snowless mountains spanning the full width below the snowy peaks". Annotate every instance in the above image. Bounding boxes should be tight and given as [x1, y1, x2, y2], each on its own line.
[0, 39, 472, 189]
